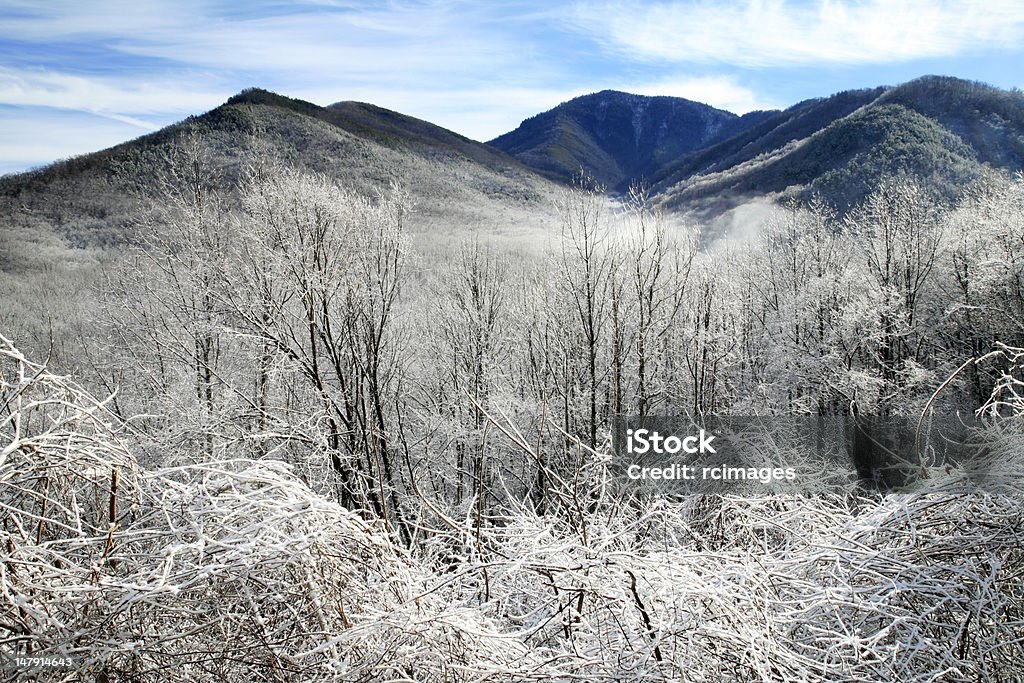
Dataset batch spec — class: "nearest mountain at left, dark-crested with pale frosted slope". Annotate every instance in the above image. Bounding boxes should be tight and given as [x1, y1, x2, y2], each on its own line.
[0, 89, 556, 253]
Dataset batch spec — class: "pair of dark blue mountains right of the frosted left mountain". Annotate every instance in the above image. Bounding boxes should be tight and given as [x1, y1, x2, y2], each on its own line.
[492, 76, 1024, 215]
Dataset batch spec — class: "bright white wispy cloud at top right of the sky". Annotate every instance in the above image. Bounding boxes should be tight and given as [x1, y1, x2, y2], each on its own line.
[570, 0, 1024, 68]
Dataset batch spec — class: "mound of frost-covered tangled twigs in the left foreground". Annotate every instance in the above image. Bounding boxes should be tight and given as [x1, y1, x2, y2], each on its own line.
[0, 340, 540, 681]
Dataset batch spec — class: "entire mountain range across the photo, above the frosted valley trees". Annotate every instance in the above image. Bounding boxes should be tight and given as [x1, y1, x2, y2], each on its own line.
[0, 76, 1024, 232]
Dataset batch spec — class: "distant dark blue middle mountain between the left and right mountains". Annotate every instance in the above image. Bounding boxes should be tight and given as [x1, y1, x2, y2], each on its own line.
[488, 90, 771, 190]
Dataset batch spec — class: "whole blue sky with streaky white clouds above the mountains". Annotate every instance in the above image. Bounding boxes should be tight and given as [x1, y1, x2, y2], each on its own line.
[0, 0, 1024, 173]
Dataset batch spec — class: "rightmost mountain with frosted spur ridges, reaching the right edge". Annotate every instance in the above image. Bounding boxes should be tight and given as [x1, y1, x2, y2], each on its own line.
[654, 76, 1024, 214]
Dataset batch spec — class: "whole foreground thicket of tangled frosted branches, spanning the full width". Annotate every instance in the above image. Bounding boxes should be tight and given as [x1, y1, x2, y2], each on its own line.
[0, 338, 1024, 682]
